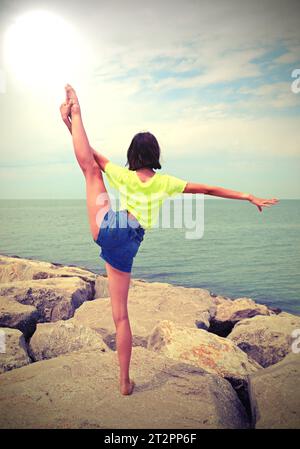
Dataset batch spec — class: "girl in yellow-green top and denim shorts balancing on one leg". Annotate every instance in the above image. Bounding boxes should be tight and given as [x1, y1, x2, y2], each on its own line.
[60, 84, 278, 395]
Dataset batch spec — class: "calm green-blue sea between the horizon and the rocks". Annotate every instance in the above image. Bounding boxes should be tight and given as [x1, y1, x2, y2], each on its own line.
[0, 199, 300, 313]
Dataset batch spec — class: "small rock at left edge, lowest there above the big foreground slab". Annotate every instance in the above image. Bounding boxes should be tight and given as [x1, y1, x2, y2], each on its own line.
[0, 327, 30, 373]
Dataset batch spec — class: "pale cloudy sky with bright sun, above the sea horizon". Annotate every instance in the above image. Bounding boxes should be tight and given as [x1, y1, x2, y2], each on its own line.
[0, 0, 300, 199]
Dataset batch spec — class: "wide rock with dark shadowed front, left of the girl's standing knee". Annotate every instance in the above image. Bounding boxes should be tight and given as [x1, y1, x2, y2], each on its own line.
[0, 277, 93, 322]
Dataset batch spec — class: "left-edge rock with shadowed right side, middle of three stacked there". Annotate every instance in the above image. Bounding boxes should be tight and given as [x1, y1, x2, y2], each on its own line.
[0, 296, 38, 338]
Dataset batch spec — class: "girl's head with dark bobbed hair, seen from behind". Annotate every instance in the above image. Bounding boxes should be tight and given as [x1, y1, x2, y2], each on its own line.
[126, 132, 161, 170]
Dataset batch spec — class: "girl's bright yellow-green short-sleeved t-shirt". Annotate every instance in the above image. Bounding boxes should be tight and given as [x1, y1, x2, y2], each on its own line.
[104, 161, 187, 229]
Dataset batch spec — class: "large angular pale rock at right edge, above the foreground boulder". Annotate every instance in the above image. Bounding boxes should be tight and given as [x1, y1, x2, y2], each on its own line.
[227, 313, 300, 367]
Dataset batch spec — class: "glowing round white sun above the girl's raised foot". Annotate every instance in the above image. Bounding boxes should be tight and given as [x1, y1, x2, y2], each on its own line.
[4, 11, 88, 88]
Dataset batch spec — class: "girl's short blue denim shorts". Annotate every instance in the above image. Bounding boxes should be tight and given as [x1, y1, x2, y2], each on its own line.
[95, 208, 145, 273]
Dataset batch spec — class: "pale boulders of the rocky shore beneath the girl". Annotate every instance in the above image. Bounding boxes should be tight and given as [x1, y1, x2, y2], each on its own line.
[0, 256, 300, 429]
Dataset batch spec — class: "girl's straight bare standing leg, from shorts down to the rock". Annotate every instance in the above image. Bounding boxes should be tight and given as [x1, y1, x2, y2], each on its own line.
[106, 263, 134, 395]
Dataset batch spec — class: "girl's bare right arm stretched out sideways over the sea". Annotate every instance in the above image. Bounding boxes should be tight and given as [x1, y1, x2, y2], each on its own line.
[183, 182, 279, 212]
